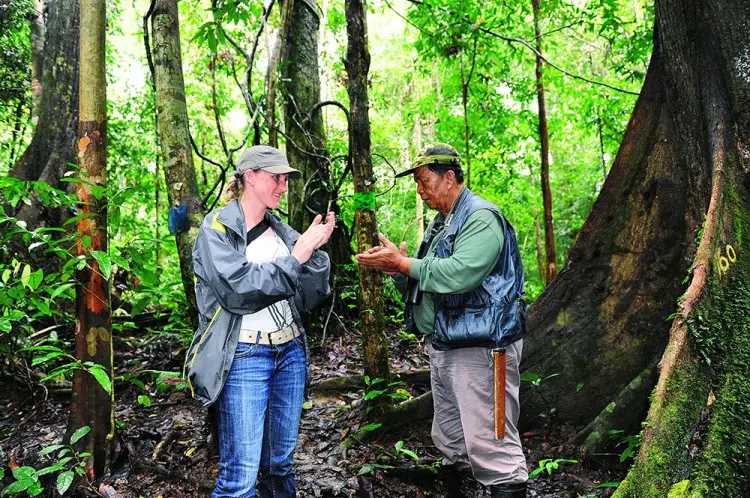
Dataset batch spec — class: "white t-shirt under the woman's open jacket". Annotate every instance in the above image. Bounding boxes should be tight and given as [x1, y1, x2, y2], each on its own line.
[241, 230, 294, 332]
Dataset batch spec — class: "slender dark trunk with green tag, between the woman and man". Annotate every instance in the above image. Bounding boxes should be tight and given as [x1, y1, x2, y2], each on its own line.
[344, 0, 390, 379]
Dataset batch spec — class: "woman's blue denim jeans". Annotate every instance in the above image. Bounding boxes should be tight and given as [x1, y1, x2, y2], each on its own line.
[211, 337, 306, 498]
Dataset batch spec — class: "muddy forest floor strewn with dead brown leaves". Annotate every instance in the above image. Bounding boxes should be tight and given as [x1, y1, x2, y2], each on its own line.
[0, 322, 626, 498]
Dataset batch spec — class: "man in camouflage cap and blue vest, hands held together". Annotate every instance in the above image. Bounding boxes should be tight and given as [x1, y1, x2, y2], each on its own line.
[357, 144, 528, 498]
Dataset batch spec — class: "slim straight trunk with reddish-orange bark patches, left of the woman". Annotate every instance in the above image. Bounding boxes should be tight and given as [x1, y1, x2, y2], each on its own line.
[67, 0, 114, 480]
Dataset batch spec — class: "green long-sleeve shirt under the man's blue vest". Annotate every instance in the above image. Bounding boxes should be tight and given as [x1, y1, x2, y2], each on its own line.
[394, 209, 504, 334]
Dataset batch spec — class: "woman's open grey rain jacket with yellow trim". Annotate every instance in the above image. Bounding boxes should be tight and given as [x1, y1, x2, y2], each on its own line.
[184, 200, 331, 406]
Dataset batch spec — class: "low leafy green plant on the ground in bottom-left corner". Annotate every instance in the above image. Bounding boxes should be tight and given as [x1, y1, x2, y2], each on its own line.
[0, 426, 93, 496]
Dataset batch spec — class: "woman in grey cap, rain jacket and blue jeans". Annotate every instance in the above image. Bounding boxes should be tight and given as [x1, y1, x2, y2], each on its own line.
[185, 146, 334, 498]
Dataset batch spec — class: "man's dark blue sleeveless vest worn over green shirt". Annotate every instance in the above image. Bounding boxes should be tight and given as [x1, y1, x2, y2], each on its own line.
[407, 188, 526, 351]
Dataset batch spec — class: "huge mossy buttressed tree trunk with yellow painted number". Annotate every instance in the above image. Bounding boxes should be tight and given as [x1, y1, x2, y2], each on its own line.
[522, 0, 750, 497]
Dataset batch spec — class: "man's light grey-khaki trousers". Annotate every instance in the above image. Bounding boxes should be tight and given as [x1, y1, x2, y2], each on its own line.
[426, 337, 528, 486]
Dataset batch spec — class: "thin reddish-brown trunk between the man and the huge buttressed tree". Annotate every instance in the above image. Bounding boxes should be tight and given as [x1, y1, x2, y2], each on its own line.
[531, 0, 557, 285]
